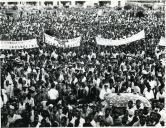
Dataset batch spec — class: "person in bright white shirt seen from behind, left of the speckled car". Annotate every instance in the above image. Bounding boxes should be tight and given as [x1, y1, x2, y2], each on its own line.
[48, 83, 59, 105]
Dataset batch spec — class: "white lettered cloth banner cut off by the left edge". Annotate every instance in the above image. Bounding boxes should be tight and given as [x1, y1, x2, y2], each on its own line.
[0, 39, 39, 49]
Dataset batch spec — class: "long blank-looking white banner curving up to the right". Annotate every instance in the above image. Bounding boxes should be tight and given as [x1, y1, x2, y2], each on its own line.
[96, 30, 145, 46]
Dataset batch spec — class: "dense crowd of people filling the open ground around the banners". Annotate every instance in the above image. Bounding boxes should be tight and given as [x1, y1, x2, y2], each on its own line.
[0, 5, 166, 127]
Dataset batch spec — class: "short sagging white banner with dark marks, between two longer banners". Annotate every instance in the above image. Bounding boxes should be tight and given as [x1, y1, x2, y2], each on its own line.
[44, 34, 81, 47]
